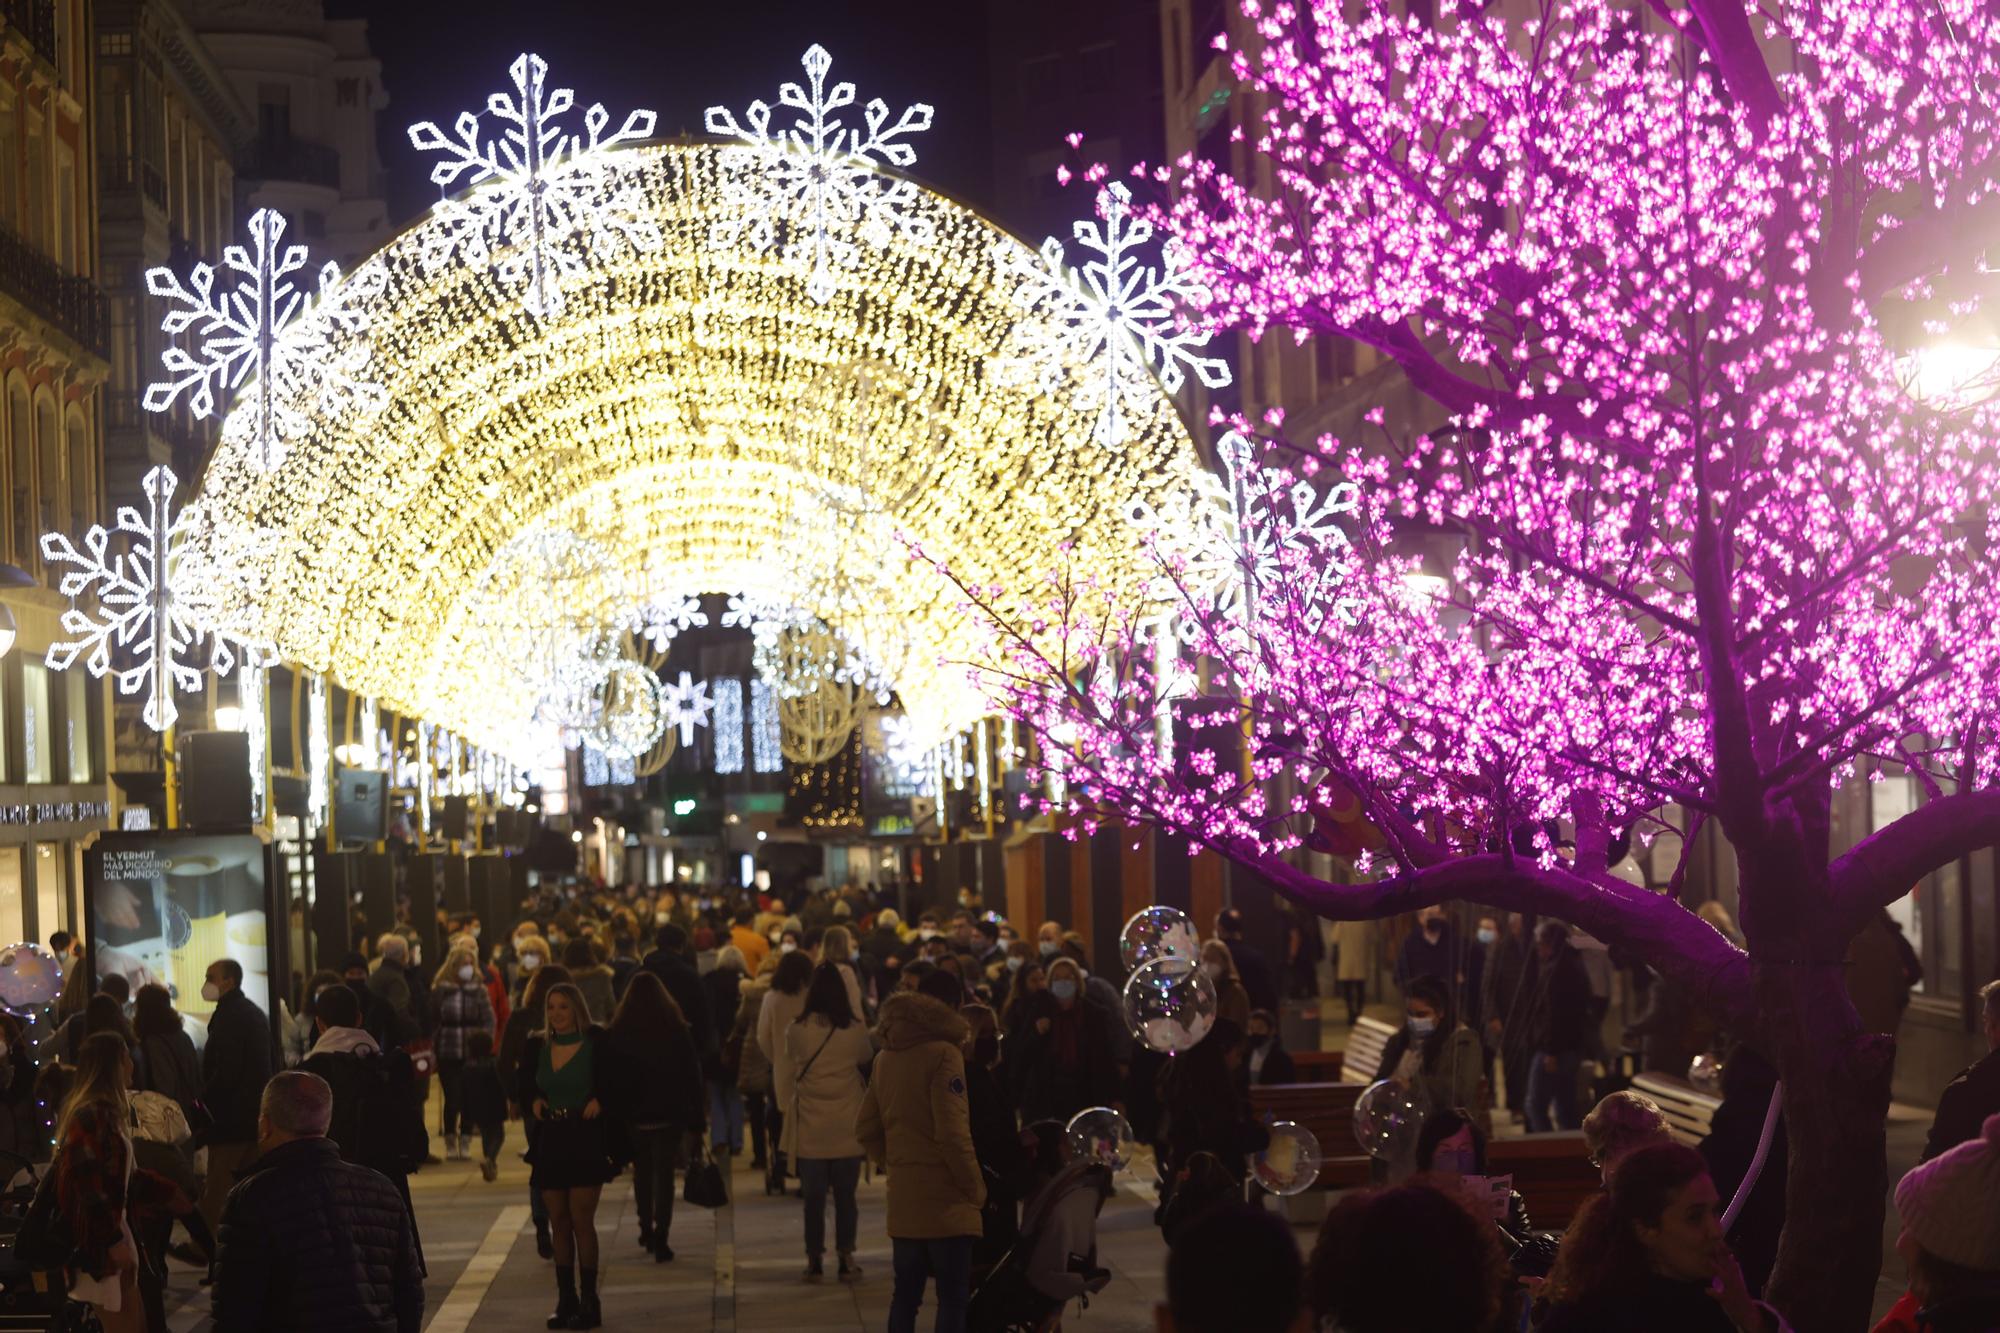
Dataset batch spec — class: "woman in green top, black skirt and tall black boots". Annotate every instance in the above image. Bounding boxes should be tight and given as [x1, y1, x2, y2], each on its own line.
[518, 983, 618, 1329]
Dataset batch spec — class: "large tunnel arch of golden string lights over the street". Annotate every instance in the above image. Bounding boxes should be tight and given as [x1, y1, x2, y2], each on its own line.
[200, 144, 1204, 753]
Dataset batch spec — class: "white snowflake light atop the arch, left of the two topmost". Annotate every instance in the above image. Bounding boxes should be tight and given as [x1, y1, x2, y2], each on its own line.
[410, 54, 662, 318]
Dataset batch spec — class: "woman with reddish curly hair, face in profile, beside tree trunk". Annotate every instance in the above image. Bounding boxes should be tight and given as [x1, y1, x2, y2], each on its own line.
[1542, 1143, 1790, 1333]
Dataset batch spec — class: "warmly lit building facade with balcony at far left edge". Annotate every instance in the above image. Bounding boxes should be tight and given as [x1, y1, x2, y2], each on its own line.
[0, 0, 110, 945]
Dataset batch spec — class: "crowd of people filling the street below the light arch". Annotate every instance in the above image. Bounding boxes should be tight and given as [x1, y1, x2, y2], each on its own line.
[11, 887, 2000, 1333]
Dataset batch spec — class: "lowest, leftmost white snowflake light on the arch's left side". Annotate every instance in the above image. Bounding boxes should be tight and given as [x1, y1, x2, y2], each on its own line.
[42, 468, 276, 731]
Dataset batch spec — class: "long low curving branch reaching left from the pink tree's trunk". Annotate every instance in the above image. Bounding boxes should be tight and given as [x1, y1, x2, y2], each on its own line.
[1210, 843, 1756, 1029]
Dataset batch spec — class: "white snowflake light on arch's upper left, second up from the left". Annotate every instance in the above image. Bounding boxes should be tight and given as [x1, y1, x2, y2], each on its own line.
[142, 208, 388, 470]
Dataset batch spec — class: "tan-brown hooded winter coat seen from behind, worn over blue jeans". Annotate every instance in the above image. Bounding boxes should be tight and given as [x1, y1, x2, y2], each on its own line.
[854, 993, 986, 1241]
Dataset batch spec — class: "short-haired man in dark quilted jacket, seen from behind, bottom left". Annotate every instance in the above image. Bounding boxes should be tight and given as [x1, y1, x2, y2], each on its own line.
[214, 1071, 424, 1333]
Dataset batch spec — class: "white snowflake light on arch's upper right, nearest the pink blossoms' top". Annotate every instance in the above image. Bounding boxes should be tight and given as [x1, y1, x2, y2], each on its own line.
[994, 182, 1230, 450]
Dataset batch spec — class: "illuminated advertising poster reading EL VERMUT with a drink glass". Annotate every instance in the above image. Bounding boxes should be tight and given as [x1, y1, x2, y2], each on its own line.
[84, 833, 272, 1043]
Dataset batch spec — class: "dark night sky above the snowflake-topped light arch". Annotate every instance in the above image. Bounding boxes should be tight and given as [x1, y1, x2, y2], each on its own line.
[326, 0, 1000, 224]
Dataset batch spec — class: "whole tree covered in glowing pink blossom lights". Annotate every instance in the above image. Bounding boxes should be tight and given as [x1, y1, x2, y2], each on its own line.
[966, 0, 2000, 1329]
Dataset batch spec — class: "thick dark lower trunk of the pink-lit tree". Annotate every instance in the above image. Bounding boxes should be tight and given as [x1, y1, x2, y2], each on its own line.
[1752, 880, 1896, 1333]
